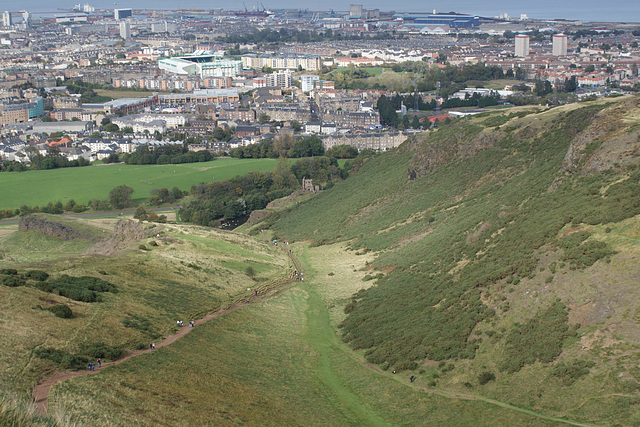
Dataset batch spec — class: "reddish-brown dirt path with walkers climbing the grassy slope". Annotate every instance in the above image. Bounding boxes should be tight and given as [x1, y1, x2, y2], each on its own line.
[33, 247, 301, 414]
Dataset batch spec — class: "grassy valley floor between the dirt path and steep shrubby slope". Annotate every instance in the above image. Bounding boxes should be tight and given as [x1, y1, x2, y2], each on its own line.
[50, 241, 568, 425]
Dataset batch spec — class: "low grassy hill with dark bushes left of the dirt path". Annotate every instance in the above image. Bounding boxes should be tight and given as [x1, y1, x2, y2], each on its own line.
[0, 215, 289, 392]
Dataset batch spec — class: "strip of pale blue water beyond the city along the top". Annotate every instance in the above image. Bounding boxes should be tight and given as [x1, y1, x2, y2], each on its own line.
[18, 0, 640, 22]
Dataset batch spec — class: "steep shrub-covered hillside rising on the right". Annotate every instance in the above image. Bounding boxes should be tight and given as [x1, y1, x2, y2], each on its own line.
[266, 97, 640, 423]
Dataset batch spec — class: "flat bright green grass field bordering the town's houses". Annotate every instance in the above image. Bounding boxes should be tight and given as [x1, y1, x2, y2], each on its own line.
[0, 158, 276, 209]
